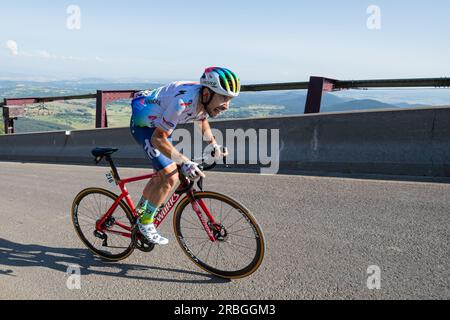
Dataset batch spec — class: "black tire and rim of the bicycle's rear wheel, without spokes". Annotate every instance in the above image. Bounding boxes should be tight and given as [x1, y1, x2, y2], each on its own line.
[72, 188, 135, 261]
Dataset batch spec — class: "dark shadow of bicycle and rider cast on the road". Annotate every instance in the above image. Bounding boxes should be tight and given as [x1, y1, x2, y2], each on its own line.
[0, 238, 230, 284]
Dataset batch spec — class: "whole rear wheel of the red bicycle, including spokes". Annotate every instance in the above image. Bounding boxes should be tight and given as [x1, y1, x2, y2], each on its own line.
[72, 188, 134, 261]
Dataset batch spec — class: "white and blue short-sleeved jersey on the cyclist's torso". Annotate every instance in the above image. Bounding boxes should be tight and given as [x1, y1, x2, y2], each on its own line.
[131, 81, 208, 134]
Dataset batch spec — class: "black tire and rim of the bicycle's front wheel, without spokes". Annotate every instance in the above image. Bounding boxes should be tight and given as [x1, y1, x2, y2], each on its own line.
[173, 191, 265, 279]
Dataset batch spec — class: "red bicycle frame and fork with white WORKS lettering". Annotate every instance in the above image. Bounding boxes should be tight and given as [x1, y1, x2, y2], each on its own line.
[96, 173, 217, 242]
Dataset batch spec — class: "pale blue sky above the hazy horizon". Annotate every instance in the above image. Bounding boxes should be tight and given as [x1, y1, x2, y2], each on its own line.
[0, 0, 450, 83]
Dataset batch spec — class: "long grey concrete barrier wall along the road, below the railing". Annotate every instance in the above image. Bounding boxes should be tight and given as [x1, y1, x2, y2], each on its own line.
[0, 107, 450, 177]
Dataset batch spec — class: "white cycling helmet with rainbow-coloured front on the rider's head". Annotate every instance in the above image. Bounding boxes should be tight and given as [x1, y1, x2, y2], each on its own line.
[200, 67, 241, 98]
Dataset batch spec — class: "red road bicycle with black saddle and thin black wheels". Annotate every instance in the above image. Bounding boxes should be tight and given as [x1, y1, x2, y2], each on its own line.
[72, 148, 265, 279]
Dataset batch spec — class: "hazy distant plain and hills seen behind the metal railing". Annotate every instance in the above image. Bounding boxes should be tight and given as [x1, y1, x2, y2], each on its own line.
[0, 78, 442, 133]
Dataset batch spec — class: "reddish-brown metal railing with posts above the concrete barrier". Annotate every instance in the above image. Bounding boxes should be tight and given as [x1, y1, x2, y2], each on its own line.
[0, 77, 450, 133]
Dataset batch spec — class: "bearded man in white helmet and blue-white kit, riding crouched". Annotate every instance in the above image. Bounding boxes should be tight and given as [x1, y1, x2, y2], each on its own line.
[130, 67, 241, 245]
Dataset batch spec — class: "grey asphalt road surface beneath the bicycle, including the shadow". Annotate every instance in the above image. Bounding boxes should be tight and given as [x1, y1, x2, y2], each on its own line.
[0, 163, 450, 300]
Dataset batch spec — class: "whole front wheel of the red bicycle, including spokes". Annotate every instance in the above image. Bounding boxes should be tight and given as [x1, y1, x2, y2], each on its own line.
[173, 192, 265, 279]
